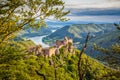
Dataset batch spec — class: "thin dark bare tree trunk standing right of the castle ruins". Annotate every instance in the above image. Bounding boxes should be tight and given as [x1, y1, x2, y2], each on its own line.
[78, 33, 90, 80]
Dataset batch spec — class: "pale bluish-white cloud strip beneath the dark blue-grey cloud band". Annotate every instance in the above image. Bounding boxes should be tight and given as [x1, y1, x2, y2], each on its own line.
[67, 16, 120, 23]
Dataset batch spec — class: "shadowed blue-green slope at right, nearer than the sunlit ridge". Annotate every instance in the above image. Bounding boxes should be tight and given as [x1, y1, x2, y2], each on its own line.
[86, 30, 120, 58]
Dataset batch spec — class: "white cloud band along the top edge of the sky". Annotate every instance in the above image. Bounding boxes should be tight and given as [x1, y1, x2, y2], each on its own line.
[63, 0, 120, 8]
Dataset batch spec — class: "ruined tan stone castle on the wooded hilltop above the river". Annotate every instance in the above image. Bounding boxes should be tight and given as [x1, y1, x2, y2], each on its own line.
[27, 37, 74, 57]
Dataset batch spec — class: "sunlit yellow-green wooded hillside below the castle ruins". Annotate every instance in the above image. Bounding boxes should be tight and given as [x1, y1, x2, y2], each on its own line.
[0, 41, 120, 80]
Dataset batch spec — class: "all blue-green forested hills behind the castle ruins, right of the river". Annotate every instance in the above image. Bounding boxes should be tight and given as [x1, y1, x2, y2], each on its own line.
[43, 23, 120, 58]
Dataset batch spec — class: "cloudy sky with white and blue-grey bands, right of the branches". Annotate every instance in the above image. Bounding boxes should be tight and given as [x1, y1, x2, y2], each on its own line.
[63, 0, 120, 23]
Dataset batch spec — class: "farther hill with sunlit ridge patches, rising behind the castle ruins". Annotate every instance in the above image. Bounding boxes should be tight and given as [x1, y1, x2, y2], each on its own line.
[44, 23, 115, 43]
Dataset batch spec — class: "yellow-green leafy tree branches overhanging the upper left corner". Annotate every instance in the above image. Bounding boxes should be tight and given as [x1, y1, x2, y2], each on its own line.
[0, 0, 69, 44]
